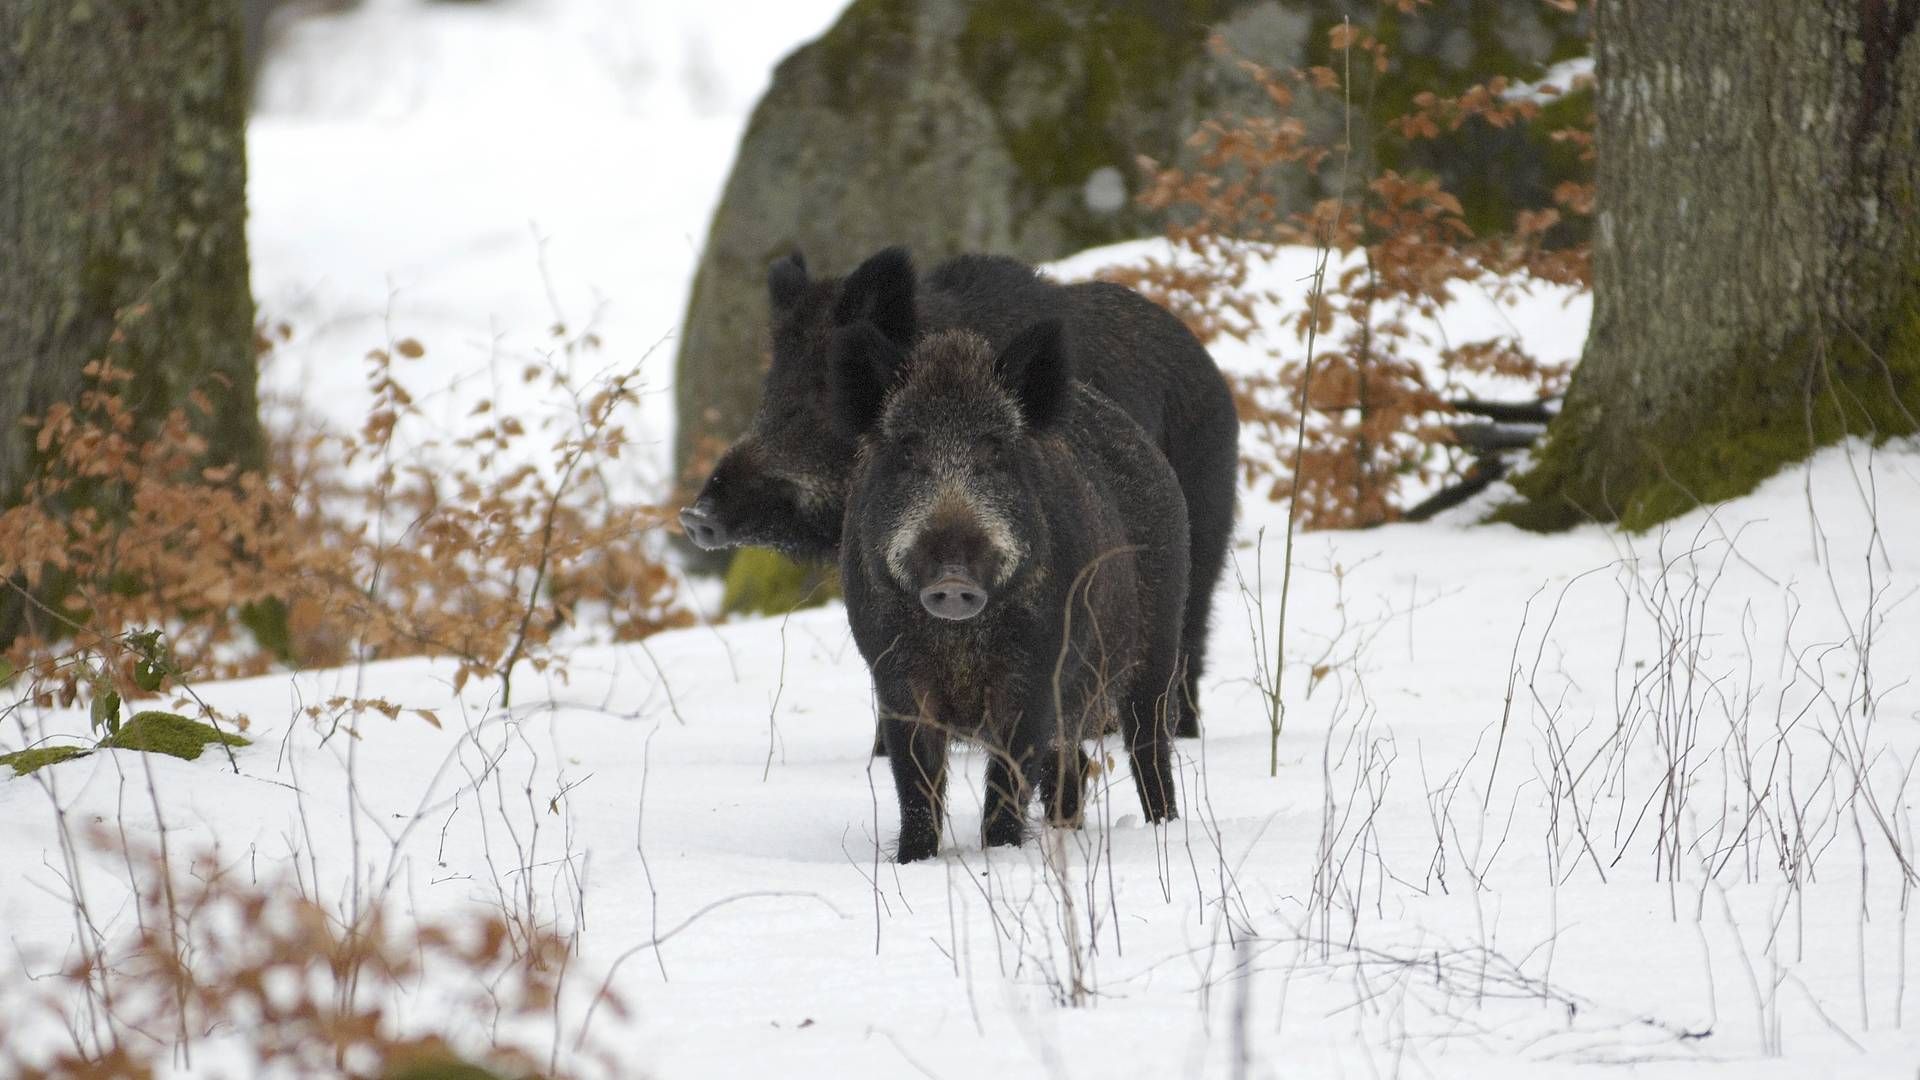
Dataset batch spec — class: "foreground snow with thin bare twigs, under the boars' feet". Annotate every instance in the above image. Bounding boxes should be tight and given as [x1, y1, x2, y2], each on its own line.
[0, 432, 1920, 1076]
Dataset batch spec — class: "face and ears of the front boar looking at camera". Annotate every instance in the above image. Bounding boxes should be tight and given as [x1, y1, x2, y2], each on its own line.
[833, 321, 1069, 621]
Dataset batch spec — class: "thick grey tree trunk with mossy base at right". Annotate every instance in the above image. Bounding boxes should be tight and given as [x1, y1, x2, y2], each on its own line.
[1503, 0, 1920, 528]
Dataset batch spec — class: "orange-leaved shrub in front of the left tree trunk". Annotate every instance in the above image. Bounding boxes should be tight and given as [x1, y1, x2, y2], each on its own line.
[0, 315, 689, 703]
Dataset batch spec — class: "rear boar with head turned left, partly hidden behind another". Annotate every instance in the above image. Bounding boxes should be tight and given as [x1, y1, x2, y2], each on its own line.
[682, 248, 1240, 736]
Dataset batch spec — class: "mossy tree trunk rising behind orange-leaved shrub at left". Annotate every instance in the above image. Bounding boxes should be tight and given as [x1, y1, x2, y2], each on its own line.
[0, 0, 263, 642]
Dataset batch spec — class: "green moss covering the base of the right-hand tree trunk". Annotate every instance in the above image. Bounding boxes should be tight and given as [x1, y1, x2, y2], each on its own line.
[1494, 258, 1920, 532]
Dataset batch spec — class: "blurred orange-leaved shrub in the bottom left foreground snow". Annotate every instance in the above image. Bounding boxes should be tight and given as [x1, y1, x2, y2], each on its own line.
[0, 828, 632, 1080]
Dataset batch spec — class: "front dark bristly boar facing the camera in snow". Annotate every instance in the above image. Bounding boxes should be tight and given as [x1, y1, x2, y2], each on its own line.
[831, 321, 1188, 863]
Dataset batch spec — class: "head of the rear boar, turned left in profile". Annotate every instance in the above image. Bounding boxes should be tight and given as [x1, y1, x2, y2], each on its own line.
[680, 248, 916, 559]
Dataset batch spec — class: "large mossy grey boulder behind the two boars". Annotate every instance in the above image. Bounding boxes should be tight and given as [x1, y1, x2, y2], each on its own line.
[674, 0, 1584, 549]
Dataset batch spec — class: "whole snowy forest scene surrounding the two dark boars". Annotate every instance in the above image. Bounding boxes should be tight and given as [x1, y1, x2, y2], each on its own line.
[0, 0, 1920, 1080]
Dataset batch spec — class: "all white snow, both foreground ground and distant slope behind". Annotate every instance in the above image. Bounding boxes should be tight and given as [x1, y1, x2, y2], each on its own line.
[0, 0, 1920, 1078]
